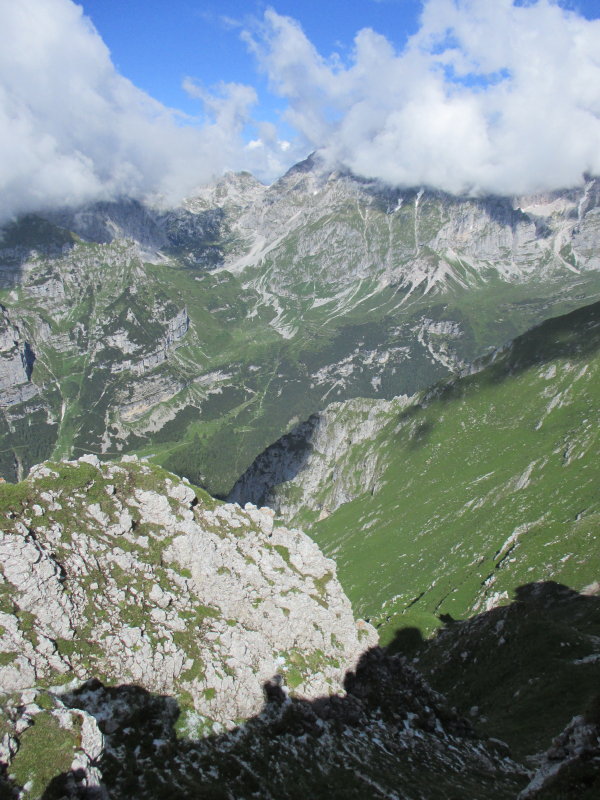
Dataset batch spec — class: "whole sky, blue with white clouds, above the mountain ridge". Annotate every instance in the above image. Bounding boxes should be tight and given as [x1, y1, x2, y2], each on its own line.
[0, 0, 600, 218]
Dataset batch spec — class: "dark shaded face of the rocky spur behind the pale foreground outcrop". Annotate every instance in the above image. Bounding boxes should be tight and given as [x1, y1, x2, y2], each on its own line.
[226, 414, 321, 508]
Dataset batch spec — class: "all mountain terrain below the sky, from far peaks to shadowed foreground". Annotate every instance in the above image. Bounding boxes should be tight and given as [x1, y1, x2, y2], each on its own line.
[0, 156, 600, 800]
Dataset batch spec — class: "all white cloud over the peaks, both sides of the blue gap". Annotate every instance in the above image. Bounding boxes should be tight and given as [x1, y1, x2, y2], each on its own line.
[0, 0, 600, 220]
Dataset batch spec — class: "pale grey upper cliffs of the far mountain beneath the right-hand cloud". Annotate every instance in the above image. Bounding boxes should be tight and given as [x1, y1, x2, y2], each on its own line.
[218, 157, 600, 292]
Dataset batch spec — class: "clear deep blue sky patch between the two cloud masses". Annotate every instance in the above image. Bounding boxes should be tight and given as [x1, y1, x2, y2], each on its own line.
[80, 0, 421, 121]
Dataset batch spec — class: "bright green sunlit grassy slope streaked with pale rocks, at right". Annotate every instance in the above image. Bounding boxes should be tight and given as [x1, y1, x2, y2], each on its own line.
[312, 304, 600, 632]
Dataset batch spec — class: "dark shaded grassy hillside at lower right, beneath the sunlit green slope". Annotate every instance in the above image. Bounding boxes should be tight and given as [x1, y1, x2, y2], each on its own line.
[413, 581, 600, 756]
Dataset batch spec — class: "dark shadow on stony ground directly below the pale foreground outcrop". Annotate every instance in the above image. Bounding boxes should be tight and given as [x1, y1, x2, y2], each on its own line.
[36, 636, 525, 800]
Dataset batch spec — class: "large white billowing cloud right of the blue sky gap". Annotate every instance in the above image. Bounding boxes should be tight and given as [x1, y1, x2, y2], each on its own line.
[251, 0, 600, 194]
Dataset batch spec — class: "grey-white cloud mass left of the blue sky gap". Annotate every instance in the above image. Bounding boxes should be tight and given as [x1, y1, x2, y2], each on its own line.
[0, 0, 289, 219]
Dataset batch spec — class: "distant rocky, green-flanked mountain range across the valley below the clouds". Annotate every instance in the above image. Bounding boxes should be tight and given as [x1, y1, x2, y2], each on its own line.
[0, 158, 600, 496]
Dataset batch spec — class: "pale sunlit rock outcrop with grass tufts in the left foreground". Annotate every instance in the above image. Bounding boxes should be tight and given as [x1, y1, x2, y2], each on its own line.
[0, 456, 375, 732]
